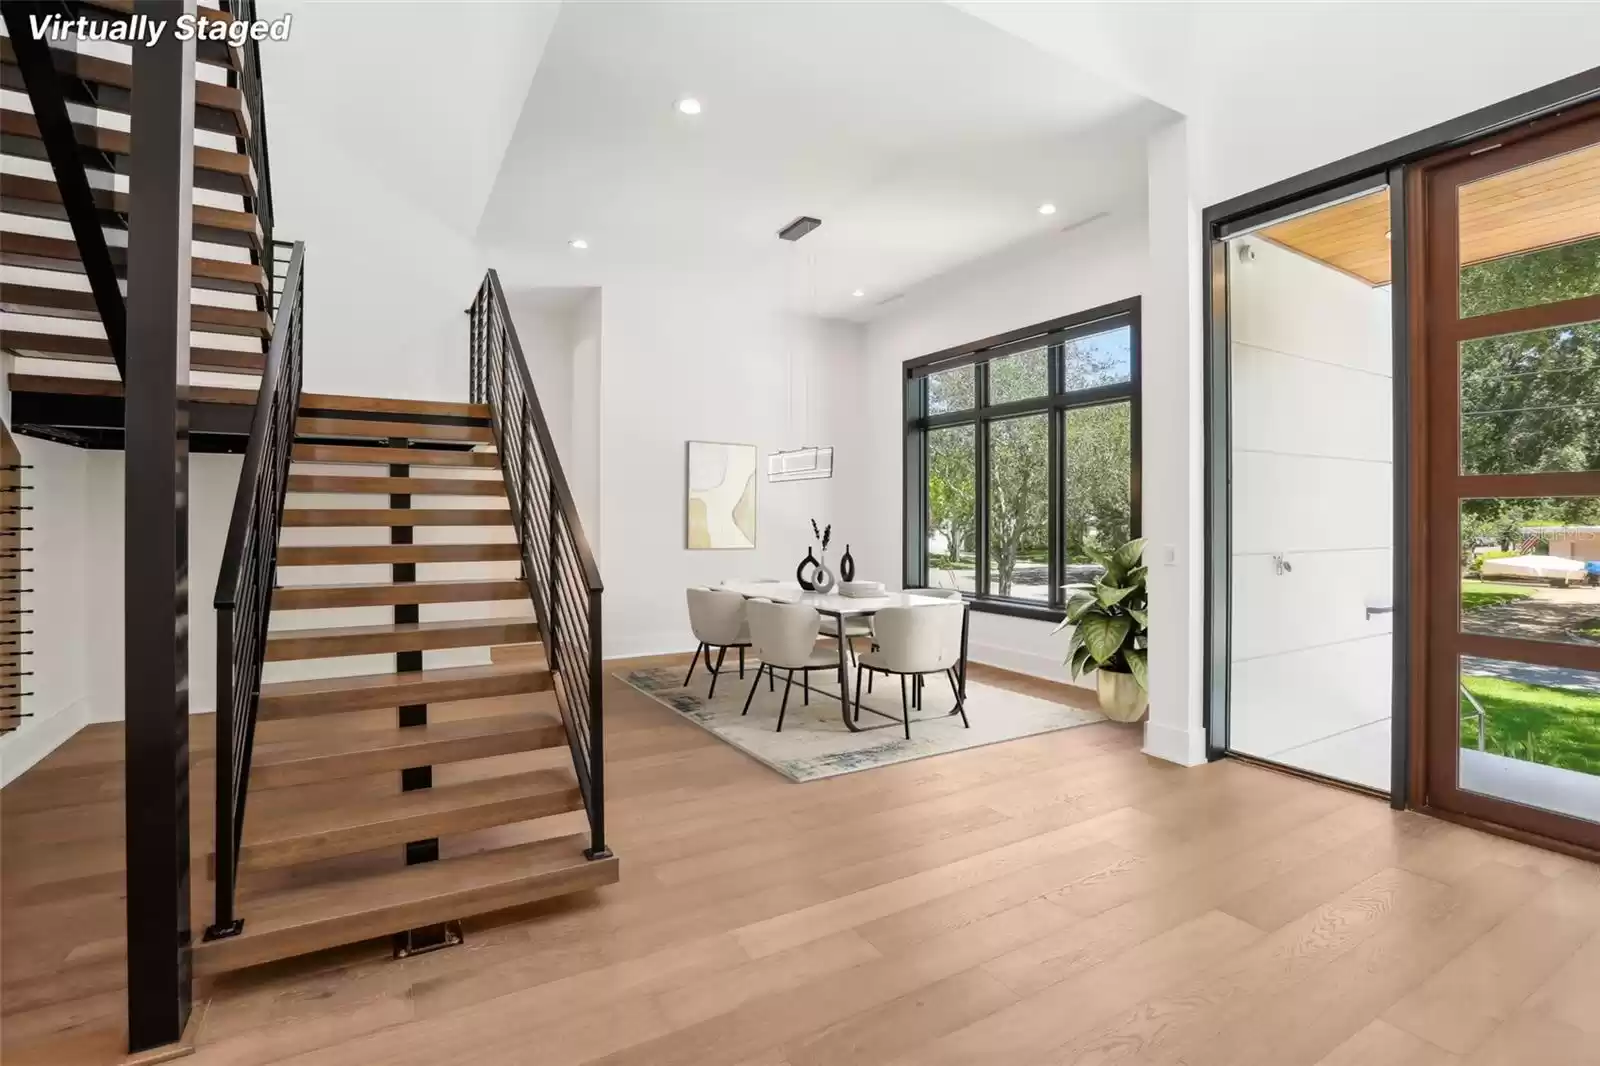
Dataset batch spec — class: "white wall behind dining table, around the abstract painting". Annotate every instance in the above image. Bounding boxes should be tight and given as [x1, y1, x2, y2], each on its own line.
[590, 274, 864, 658]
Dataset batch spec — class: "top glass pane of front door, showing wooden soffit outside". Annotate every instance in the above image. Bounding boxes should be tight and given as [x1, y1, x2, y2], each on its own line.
[1458, 144, 1600, 319]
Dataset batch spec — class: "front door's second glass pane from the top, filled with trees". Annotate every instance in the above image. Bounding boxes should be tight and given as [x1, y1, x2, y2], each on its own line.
[1461, 315, 1600, 474]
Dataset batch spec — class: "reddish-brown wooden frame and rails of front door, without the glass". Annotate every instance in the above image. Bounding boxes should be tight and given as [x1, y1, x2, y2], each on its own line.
[1403, 101, 1600, 861]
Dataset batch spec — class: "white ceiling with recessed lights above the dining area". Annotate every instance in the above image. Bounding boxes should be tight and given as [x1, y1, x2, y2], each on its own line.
[477, 0, 1170, 317]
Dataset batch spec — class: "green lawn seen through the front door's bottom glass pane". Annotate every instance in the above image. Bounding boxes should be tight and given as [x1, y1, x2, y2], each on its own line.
[1461, 677, 1600, 775]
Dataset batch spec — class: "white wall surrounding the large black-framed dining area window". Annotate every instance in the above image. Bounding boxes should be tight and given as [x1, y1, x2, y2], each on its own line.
[837, 206, 1154, 683]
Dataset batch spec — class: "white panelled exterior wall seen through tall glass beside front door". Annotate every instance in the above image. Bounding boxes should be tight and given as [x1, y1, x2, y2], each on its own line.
[1229, 237, 1394, 757]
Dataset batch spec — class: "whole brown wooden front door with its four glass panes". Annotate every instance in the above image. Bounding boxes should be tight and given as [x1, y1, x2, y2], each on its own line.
[1418, 112, 1600, 850]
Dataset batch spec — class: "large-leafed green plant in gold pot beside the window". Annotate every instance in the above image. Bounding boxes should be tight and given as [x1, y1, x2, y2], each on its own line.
[1056, 538, 1150, 722]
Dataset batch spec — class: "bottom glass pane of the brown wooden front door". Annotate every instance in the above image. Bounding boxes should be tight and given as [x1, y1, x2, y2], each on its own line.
[1458, 656, 1600, 823]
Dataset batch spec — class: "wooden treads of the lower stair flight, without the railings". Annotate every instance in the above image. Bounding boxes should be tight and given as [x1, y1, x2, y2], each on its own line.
[194, 307, 618, 975]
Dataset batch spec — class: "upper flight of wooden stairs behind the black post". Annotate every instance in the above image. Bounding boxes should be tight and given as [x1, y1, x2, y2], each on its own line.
[0, 0, 275, 438]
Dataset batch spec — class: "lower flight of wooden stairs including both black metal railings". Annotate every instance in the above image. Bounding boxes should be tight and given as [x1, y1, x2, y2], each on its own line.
[195, 256, 618, 973]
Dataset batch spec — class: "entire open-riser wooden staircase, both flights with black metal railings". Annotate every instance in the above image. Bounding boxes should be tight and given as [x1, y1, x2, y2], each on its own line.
[0, 0, 618, 975]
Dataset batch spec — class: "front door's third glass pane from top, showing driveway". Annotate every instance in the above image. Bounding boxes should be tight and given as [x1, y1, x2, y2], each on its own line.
[1459, 496, 1600, 650]
